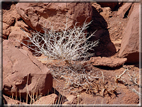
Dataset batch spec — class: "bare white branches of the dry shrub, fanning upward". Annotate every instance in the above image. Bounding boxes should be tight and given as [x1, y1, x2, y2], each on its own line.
[21, 18, 98, 61]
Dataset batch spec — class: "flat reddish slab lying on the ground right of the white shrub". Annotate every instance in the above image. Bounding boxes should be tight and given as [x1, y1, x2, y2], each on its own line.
[90, 57, 127, 68]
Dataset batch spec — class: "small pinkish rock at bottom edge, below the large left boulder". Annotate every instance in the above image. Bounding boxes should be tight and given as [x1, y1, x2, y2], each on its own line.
[33, 94, 58, 105]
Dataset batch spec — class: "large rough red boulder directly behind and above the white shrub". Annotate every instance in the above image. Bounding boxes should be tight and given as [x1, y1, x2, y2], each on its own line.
[16, 3, 92, 32]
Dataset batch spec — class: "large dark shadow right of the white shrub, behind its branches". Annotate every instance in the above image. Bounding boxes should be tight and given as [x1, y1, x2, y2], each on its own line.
[88, 6, 116, 57]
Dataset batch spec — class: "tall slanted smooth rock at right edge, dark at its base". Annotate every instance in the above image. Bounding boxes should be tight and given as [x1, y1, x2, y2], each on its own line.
[119, 3, 139, 63]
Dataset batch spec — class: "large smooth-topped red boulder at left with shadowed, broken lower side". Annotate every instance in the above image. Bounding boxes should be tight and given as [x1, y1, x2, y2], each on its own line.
[3, 40, 53, 98]
